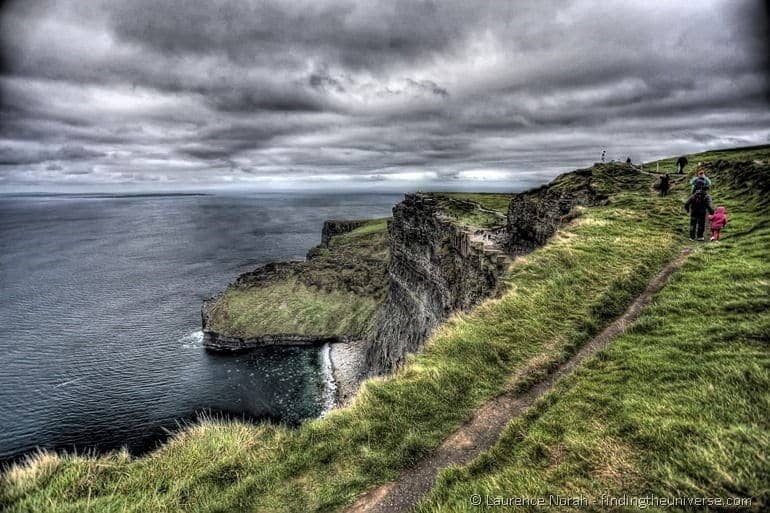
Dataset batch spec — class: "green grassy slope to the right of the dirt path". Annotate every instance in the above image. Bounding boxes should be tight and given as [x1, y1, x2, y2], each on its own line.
[420, 151, 770, 512]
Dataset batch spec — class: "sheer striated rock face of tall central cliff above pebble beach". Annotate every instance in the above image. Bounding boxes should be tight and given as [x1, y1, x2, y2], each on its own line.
[366, 194, 507, 374]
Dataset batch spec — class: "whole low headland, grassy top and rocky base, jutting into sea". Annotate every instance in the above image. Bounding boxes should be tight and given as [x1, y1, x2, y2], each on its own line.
[201, 219, 388, 351]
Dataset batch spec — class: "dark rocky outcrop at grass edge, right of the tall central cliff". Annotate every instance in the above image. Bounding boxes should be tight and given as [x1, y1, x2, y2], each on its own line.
[506, 169, 607, 253]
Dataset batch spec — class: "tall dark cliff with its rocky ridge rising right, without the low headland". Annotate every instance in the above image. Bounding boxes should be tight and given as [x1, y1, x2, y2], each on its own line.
[366, 164, 649, 374]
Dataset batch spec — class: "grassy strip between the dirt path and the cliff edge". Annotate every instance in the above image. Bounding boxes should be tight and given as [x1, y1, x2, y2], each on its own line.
[0, 146, 766, 512]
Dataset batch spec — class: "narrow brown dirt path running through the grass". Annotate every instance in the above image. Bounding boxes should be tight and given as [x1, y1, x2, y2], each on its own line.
[346, 248, 691, 513]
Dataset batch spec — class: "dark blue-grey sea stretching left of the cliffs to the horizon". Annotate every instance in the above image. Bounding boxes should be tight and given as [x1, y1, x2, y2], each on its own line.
[0, 194, 400, 462]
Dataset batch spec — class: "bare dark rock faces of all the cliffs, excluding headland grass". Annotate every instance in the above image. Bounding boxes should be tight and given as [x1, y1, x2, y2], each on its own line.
[202, 166, 624, 374]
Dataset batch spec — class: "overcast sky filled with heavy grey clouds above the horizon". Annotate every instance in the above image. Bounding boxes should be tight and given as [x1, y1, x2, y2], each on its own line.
[0, 0, 770, 192]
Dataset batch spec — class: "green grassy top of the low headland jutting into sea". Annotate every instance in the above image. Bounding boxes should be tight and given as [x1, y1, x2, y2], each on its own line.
[206, 219, 388, 337]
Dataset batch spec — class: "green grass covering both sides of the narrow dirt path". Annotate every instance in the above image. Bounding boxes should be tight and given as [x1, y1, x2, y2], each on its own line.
[0, 146, 770, 512]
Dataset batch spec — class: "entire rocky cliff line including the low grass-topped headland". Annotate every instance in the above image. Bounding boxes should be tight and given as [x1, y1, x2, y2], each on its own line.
[202, 164, 649, 374]
